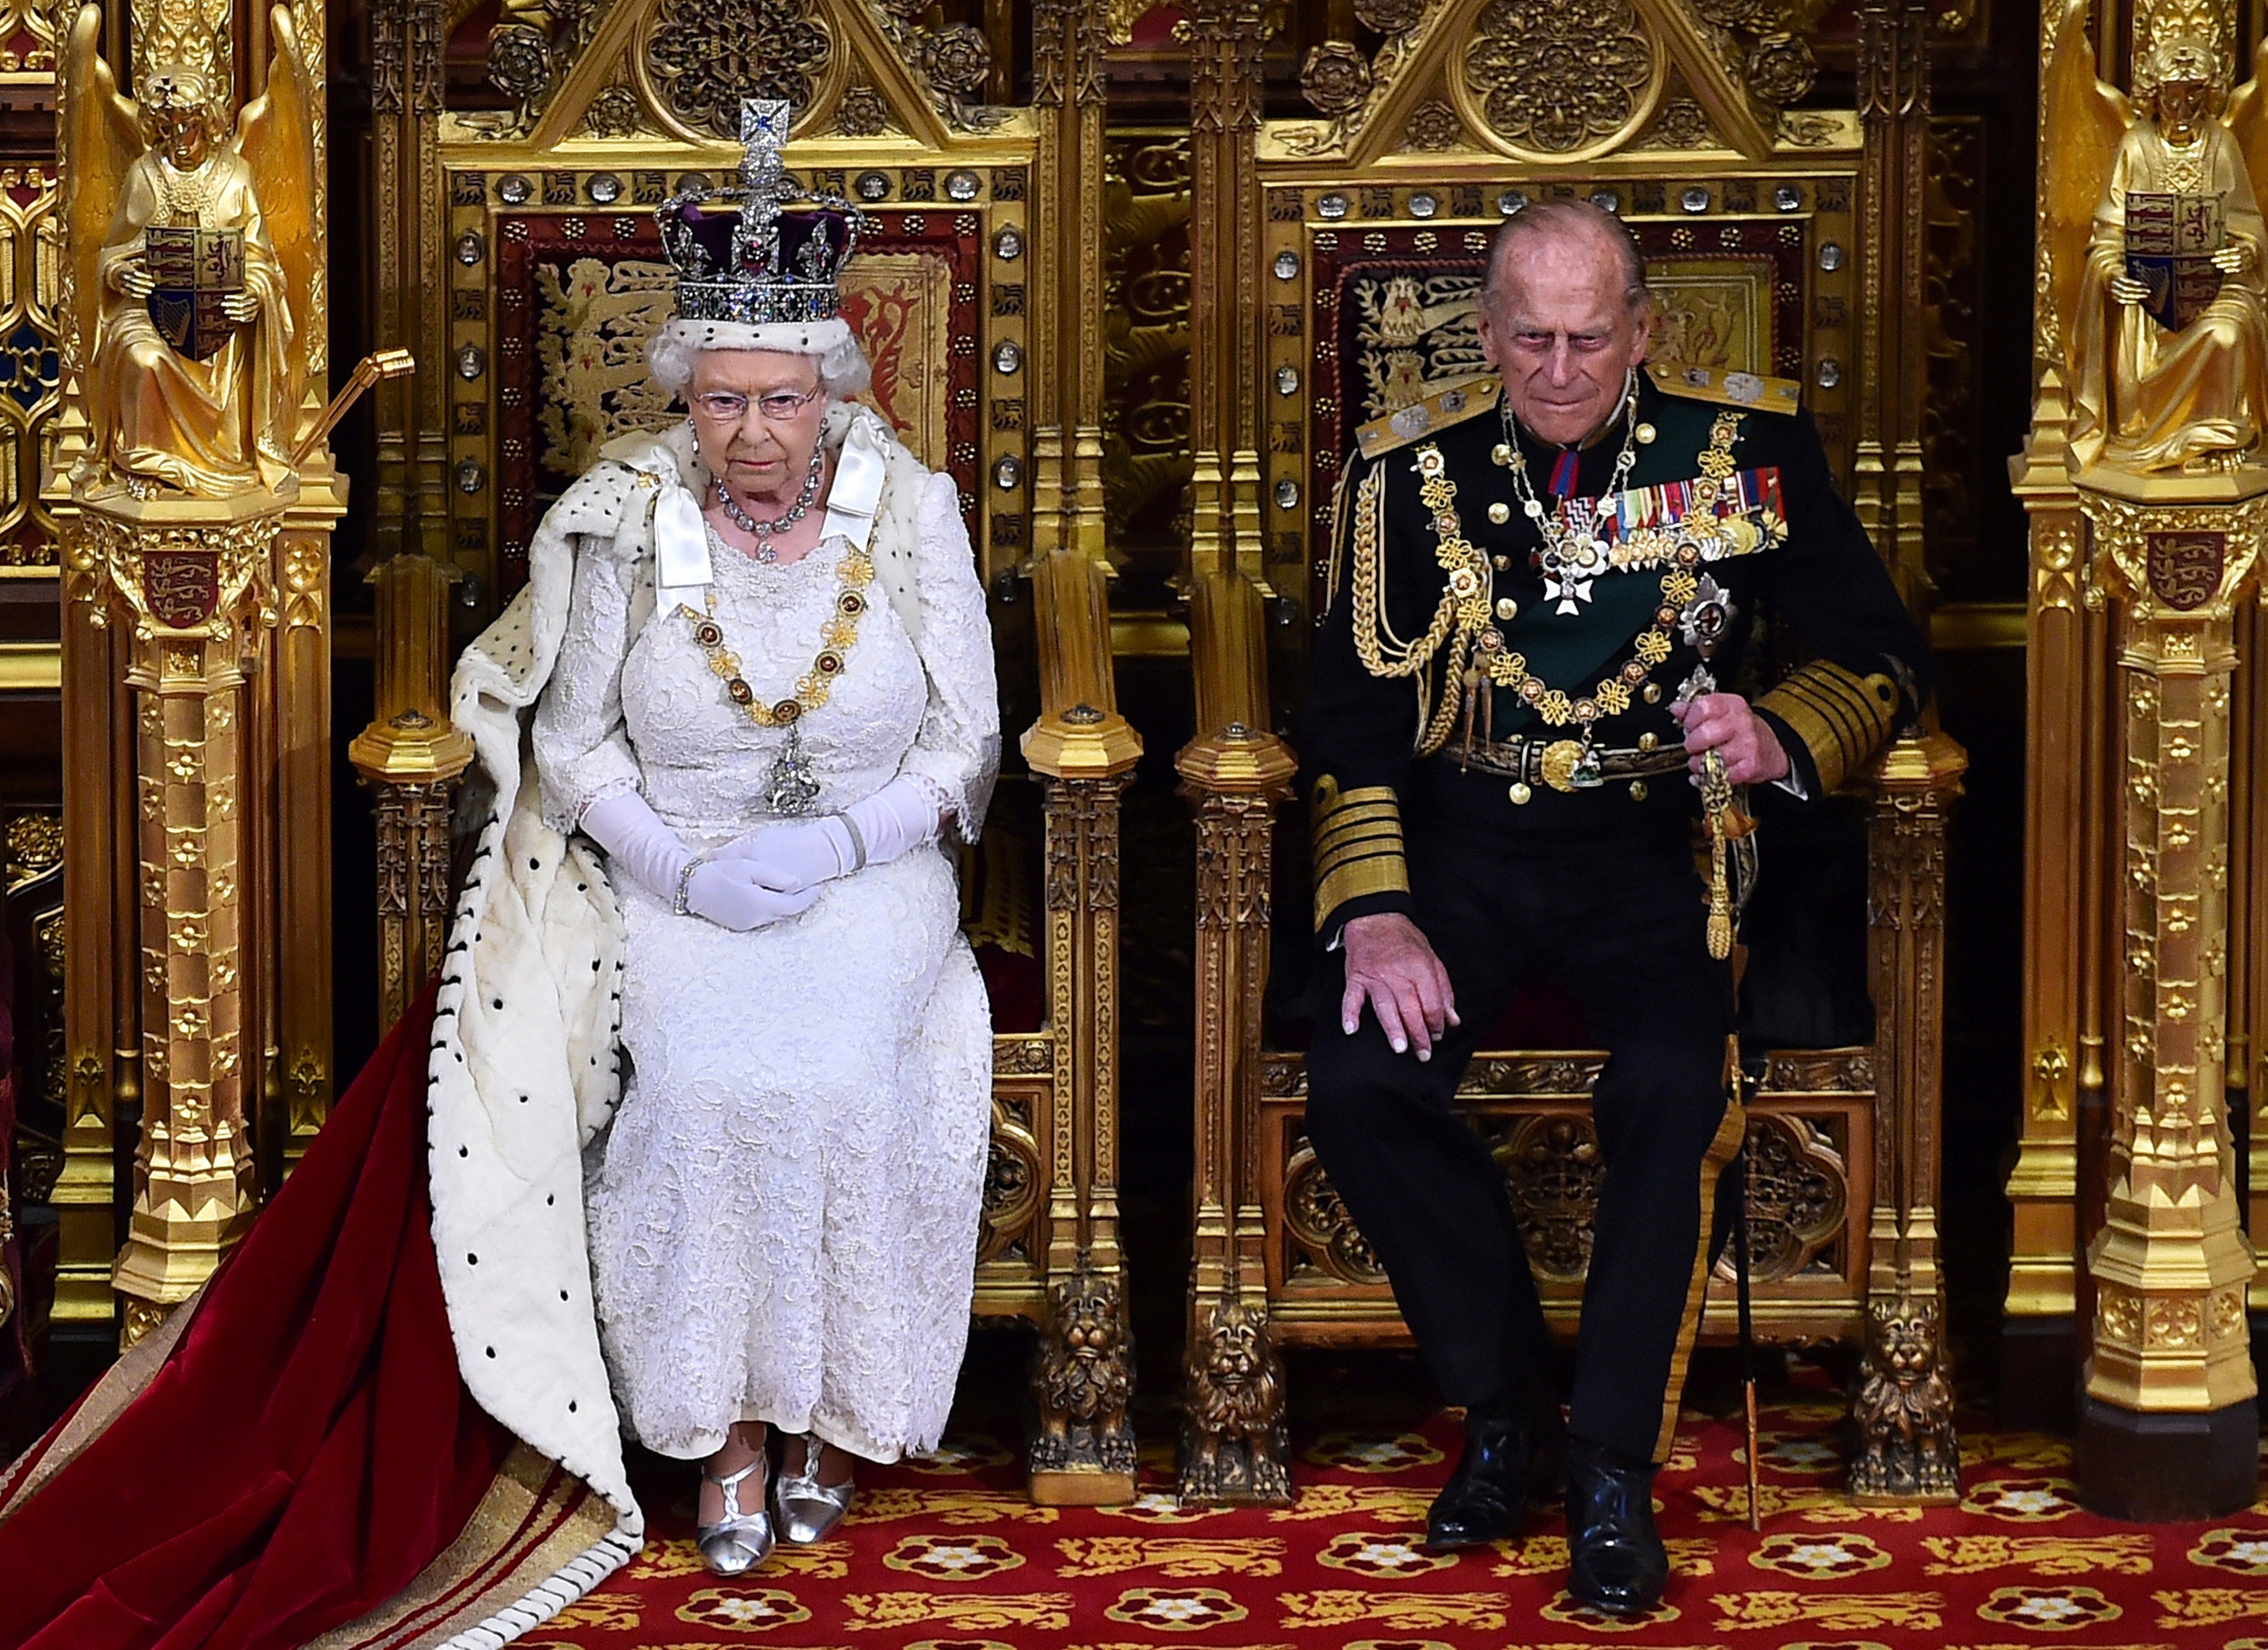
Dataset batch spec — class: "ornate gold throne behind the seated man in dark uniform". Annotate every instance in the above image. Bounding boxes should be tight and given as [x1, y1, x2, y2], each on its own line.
[1179, 0, 1964, 1500]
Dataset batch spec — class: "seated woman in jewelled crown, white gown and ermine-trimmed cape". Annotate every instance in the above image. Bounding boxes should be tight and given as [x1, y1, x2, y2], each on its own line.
[431, 107, 998, 1575]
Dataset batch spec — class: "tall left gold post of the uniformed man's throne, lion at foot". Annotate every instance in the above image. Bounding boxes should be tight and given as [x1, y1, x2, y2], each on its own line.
[1175, 0, 1297, 1503]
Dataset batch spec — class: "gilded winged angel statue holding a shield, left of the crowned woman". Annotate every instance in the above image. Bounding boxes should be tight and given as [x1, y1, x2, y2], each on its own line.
[63, 4, 317, 497]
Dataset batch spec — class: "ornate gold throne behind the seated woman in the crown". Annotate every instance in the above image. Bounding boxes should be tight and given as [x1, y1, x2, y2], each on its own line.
[356, 0, 1141, 1503]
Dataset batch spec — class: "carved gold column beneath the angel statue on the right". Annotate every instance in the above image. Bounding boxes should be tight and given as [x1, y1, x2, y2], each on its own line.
[2075, 488, 2268, 1519]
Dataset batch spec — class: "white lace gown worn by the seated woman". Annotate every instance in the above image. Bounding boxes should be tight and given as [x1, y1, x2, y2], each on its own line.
[533, 477, 1000, 1461]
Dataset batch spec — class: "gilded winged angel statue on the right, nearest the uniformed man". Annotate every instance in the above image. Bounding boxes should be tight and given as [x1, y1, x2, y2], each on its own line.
[2046, 0, 2268, 474]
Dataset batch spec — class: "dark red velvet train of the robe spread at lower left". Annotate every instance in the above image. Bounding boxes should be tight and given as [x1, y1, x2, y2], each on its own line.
[0, 987, 513, 1650]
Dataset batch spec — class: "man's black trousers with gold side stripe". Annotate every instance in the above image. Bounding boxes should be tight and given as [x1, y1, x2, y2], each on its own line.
[1306, 794, 1744, 1461]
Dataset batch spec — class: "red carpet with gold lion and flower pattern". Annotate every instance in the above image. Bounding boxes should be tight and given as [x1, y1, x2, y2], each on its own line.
[522, 1394, 2268, 1650]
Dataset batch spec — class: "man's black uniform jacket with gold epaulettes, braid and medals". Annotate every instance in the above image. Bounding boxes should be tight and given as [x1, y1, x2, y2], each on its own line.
[1302, 365, 1928, 942]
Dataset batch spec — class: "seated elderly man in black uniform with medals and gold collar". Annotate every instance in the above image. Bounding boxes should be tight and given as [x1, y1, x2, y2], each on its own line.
[1304, 202, 1928, 1614]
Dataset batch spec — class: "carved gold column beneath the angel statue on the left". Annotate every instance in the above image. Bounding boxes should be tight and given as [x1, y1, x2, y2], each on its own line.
[66, 492, 284, 1344]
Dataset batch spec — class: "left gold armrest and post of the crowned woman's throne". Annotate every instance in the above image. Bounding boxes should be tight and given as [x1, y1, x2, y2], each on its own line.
[347, 554, 472, 1035]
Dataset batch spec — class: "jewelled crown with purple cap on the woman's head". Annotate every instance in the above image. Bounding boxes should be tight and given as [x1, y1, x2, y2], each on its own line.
[653, 97, 866, 327]
